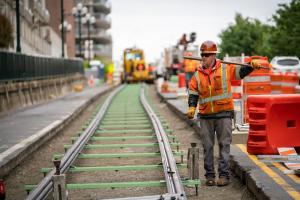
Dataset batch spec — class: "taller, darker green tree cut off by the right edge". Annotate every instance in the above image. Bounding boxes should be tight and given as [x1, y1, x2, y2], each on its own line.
[270, 0, 300, 57]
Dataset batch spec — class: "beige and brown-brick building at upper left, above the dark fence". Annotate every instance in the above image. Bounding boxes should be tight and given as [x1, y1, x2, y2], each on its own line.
[0, 0, 75, 57]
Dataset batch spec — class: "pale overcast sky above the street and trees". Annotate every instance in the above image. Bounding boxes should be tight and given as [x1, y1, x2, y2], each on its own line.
[110, 0, 291, 61]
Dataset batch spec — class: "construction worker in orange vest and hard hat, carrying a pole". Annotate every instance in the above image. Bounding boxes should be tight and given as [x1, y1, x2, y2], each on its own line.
[187, 41, 259, 186]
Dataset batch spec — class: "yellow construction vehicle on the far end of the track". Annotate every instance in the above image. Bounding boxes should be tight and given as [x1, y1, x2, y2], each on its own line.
[122, 47, 154, 83]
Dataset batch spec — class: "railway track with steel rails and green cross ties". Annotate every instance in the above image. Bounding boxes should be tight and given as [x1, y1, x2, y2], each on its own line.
[25, 85, 200, 200]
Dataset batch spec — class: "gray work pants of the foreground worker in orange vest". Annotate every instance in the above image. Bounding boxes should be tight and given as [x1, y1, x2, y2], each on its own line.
[199, 118, 232, 178]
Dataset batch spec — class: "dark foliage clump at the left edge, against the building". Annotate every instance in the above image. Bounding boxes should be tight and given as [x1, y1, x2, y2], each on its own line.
[0, 15, 14, 48]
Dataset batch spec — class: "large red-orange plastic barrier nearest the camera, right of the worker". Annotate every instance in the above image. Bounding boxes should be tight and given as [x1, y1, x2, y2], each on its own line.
[247, 94, 300, 154]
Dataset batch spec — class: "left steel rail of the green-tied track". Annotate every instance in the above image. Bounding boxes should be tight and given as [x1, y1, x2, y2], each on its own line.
[26, 85, 124, 200]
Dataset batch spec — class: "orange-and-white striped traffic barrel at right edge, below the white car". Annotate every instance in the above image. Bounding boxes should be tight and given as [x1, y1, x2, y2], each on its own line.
[281, 72, 299, 94]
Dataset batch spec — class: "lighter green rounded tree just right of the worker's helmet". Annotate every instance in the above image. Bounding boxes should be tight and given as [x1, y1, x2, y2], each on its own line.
[219, 13, 271, 57]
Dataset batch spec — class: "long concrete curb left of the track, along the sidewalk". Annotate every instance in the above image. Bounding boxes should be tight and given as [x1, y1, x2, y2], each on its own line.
[0, 86, 115, 177]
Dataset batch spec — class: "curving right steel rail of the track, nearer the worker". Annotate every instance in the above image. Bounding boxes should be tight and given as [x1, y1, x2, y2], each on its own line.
[140, 85, 187, 200]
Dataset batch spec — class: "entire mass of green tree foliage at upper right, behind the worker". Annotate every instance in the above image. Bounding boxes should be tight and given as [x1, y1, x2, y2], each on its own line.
[219, 0, 300, 57]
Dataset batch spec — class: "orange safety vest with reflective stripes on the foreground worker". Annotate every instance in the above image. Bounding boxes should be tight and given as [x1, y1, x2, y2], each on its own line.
[189, 60, 241, 115]
